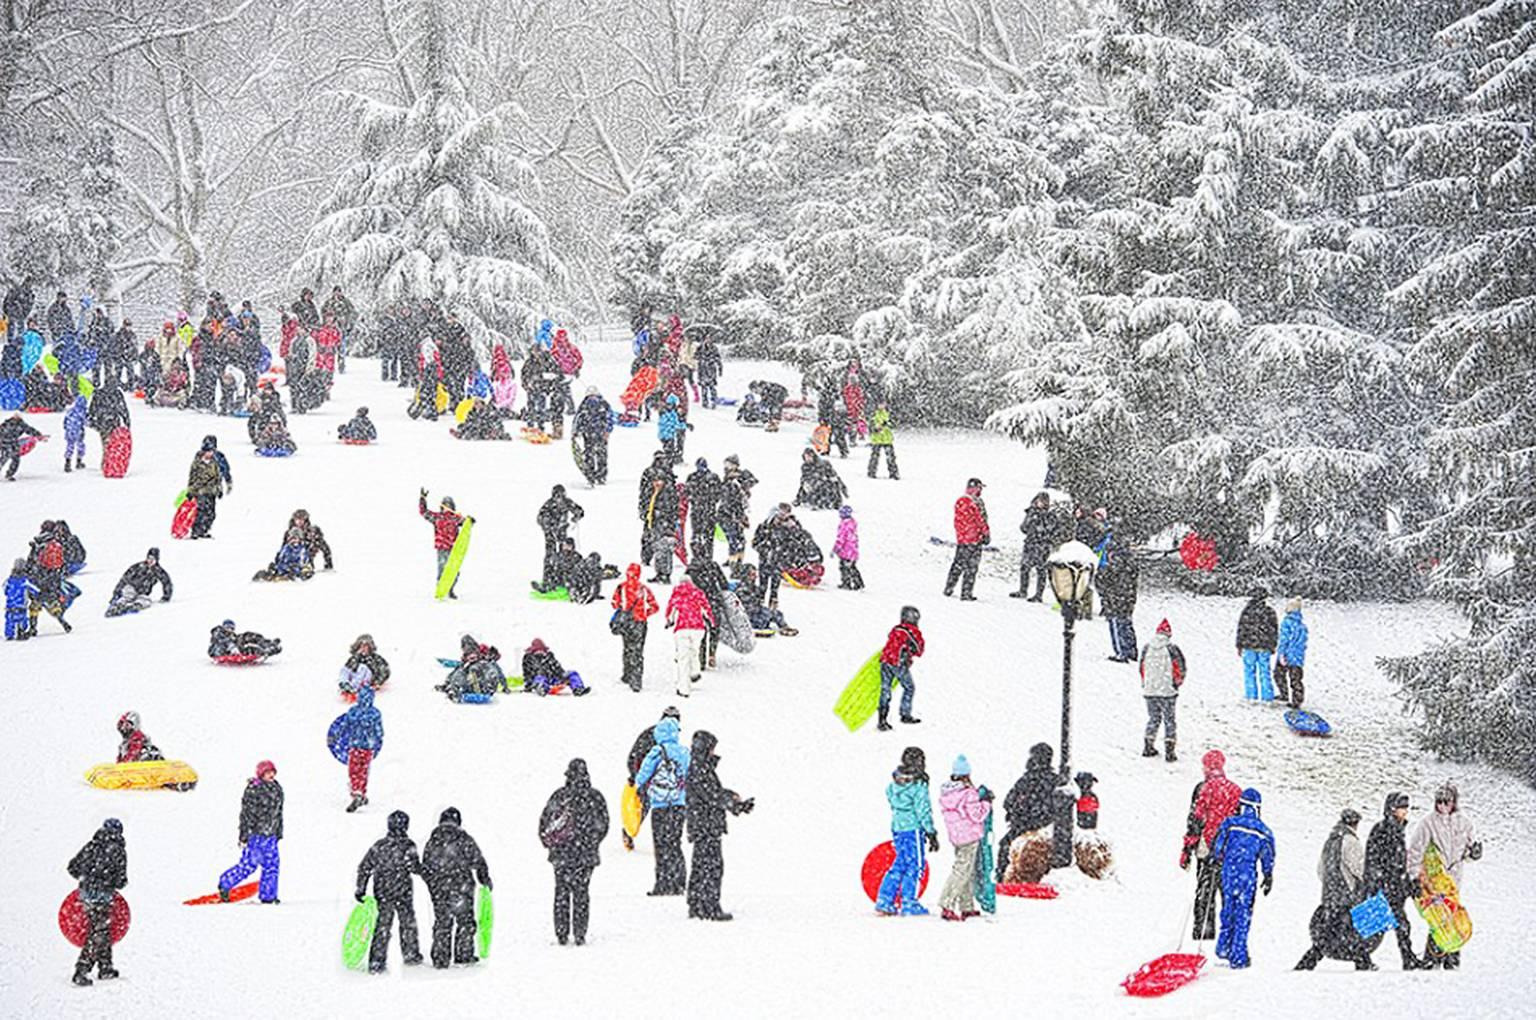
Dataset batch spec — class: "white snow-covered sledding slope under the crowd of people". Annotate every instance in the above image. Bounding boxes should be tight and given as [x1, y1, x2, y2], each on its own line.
[0, 337, 1536, 1017]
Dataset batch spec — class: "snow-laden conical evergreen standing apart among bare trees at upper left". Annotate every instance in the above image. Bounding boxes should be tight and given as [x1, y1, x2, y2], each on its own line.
[290, 0, 564, 341]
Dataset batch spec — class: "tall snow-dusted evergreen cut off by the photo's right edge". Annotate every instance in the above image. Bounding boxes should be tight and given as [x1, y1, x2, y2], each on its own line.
[1384, 0, 1536, 782]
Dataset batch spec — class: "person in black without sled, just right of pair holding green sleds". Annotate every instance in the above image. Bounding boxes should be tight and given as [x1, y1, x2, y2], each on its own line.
[539, 757, 608, 946]
